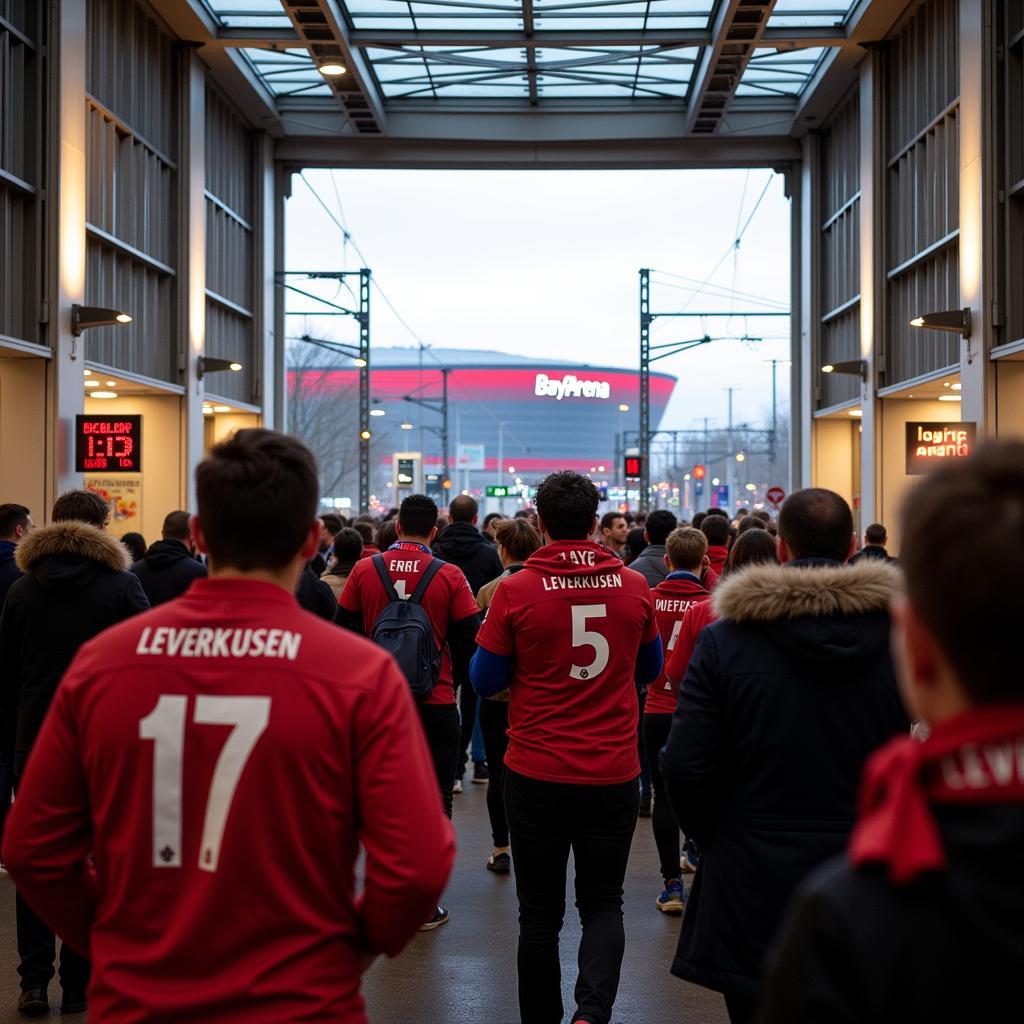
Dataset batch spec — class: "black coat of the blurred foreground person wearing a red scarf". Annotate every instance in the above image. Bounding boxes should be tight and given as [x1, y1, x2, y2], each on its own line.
[760, 805, 1024, 1024]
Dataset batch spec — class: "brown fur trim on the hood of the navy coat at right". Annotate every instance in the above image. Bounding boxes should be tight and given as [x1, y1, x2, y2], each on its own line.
[715, 559, 903, 623]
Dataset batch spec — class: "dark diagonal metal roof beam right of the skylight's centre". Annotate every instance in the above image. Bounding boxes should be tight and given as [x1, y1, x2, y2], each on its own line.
[686, 0, 777, 135]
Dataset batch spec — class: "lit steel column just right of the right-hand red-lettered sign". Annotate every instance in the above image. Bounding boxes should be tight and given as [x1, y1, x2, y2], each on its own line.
[958, 0, 997, 434]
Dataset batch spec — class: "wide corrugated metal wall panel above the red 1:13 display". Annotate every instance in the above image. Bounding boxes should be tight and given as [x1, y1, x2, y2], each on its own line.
[85, 0, 180, 383]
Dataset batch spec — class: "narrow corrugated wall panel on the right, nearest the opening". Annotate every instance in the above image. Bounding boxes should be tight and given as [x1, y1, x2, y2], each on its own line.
[818, 91, 860, 409]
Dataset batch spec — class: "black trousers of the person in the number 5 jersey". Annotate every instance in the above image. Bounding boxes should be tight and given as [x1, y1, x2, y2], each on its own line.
[505, 769, 640, 1024]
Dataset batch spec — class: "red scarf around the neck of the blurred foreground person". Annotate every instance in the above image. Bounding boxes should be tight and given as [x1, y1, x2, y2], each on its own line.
[850, 703, 1024, 885]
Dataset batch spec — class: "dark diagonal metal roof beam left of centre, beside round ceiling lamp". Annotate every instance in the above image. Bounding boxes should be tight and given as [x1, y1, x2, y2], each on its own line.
[278, 0, 384, 135]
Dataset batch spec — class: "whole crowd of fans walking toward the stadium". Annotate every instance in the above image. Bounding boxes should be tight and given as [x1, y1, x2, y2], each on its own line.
[0, 429, 1024, 1024]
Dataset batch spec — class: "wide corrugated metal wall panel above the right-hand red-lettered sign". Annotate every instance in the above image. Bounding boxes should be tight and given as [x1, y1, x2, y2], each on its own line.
[884, 0, 959, 385]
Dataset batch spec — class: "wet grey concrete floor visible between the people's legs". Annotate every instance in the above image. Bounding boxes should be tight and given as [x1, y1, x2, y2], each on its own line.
[0, 785, 728, 1024]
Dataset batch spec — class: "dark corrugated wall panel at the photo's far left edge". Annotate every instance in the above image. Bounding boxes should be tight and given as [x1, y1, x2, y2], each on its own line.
[0, 0, 46, 343]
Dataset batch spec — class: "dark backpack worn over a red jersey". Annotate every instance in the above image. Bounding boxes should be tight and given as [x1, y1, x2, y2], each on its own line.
[370, 555, 444, 700]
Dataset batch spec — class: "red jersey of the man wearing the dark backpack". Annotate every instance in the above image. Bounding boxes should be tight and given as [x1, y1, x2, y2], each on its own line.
[338, 543, 480, 705]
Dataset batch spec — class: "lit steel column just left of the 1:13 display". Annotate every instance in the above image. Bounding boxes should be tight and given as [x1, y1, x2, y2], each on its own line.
[45, 0, 88, 507]
